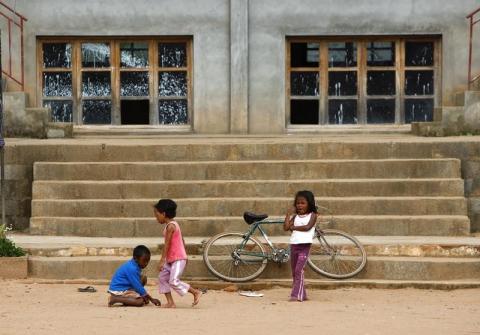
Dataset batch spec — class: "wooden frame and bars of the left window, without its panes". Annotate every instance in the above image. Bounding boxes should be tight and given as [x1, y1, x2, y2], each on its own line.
[37, 36, 194, 131]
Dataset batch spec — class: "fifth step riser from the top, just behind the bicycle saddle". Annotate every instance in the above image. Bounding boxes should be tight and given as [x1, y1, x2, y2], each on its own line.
[30, 217, 470, 237]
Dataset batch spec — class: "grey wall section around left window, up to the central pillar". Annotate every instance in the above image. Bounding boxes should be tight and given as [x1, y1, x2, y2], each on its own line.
[9, 0, 230, 133]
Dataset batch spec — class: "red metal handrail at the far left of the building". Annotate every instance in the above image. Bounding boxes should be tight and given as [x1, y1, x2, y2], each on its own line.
[0, 0, 28, 91]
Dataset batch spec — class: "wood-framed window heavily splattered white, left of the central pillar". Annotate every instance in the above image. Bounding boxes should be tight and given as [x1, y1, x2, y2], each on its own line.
[38, 38, 192, 126]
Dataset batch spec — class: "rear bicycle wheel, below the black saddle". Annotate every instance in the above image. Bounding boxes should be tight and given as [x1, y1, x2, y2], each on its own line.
[203, 233, 267, 283]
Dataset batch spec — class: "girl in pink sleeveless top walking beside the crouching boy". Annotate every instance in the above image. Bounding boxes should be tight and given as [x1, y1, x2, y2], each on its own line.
[154, 199, 202, 308]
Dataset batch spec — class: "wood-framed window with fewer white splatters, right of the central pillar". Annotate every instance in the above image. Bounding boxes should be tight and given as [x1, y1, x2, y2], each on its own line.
[286, 37, 440, 127]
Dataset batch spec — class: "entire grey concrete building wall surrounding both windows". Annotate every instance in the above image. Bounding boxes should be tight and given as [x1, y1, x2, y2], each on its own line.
[0, 0, 480, 133]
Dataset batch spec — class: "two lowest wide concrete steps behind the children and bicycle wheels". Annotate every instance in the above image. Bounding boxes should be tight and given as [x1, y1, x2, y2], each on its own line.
[13, 236, 480, 281]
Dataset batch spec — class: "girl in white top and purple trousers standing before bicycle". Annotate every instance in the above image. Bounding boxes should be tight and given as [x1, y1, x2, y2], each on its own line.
[283, 191, 317, 301]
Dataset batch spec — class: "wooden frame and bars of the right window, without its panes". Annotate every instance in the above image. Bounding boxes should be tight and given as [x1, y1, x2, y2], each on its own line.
[285, 35, 442, 130]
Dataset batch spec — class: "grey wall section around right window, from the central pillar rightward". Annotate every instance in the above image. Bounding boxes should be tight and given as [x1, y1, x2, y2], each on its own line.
[249, 0, 480, 133]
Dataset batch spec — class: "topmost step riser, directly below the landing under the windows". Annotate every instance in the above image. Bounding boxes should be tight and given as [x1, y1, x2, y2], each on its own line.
[12, 142, 478, 162]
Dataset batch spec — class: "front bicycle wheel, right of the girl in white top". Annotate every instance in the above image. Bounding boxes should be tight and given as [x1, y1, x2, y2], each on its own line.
[308, 229, 367, 279]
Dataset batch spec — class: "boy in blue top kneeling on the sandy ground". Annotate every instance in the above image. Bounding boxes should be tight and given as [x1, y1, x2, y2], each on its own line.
[108, 245, 160, 307]
